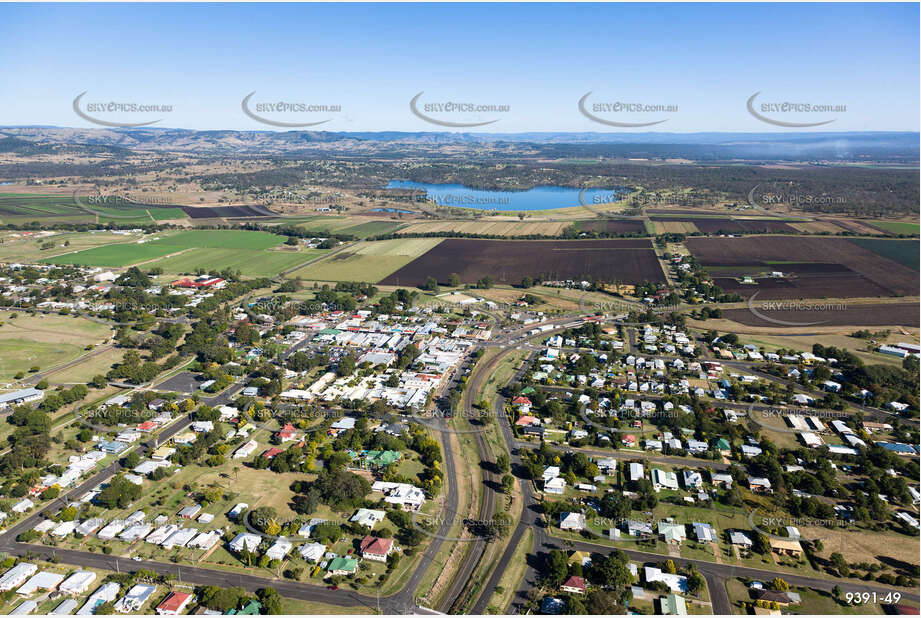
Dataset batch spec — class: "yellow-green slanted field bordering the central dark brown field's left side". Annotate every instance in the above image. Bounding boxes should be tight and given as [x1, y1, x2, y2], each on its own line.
[288, 238, 442, 282]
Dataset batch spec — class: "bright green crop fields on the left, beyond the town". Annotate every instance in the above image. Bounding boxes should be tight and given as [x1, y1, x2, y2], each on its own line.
[44, 230, 323, 277]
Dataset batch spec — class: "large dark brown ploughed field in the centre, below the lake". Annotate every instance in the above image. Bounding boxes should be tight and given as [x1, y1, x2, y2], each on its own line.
[379, 238, 665, 286]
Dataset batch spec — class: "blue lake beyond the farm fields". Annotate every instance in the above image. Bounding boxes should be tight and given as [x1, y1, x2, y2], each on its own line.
[387, 180, 630, 211]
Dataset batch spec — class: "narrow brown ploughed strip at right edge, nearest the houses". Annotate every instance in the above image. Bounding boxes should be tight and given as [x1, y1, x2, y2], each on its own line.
[723, 302, 921, 328]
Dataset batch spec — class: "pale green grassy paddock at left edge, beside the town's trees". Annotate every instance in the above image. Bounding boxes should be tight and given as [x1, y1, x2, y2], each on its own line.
[0, 311, 111, 381]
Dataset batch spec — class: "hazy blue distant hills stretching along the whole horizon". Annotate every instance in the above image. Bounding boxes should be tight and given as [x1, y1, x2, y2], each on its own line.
[0, 127, 919, 163]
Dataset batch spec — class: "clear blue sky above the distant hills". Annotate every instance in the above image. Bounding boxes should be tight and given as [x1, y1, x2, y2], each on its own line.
[0, 3, 919, 133]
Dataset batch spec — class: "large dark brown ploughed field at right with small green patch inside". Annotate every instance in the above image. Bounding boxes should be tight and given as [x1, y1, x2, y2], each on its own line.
[685, 236, 918, 300]
